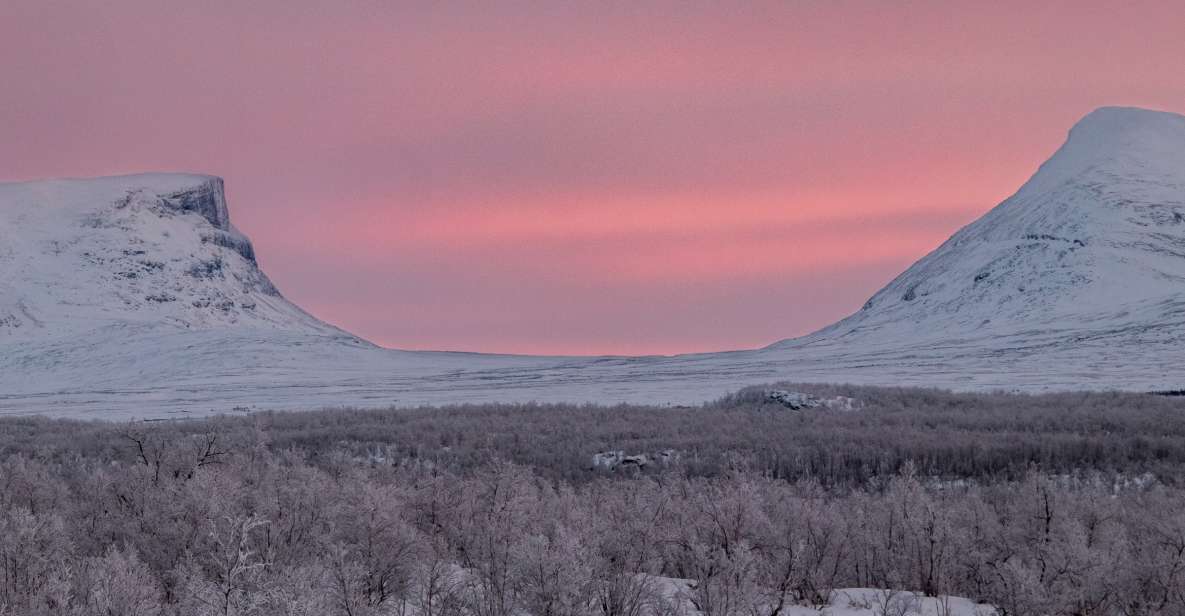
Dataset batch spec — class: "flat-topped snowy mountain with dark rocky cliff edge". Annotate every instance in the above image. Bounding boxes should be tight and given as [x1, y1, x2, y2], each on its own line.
[0, 174, 353, 341]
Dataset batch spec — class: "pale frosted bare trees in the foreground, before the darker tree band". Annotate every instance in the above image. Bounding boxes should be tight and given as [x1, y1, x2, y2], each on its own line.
[0, 431, 1185, 616]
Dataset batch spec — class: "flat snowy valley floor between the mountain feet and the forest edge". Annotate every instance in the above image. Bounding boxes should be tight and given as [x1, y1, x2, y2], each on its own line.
[0, 317, 1185, 419]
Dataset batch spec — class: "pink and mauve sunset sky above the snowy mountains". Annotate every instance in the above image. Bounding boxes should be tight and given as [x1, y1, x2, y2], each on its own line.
[0, 0, 1185, 354]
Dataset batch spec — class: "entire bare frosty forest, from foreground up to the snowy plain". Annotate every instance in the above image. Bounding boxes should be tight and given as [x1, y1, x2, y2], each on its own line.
[0, 384, 1185, 616]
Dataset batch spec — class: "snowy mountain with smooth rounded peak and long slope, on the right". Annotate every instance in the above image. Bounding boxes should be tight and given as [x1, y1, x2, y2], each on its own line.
[774, 108, 1185, 348]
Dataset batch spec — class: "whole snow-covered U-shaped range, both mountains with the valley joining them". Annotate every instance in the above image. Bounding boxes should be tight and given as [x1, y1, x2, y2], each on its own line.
[0, 108, 1185, 417]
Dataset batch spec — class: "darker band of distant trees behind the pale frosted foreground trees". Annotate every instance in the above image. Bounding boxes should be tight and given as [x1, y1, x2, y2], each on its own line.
[0, 385, 1185, 489]
